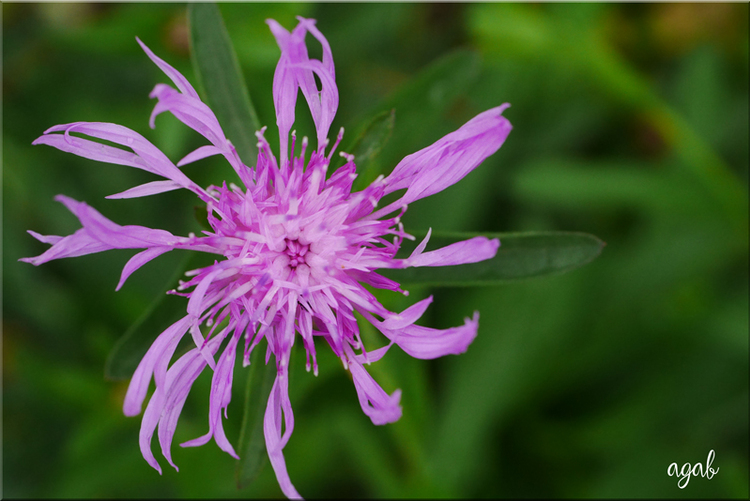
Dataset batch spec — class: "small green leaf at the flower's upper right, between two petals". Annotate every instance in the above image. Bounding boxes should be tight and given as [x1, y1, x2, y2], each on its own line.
[348, 110, 396, 191]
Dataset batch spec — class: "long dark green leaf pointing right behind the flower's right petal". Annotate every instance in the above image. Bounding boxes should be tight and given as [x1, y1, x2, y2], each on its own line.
[380, 231, 605, 287]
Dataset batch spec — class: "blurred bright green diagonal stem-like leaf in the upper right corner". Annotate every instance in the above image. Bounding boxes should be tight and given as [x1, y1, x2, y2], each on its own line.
[470, 4, 748, 234]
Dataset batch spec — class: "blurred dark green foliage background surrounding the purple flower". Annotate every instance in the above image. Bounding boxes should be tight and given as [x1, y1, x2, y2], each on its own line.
[2, 3, 748, 498]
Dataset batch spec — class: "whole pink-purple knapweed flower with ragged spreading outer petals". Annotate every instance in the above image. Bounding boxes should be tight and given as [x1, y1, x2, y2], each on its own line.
[22, 18, 511, 497]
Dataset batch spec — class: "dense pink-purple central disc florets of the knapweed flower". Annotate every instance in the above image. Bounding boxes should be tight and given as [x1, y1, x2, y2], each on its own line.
[184, 125, 413, 374]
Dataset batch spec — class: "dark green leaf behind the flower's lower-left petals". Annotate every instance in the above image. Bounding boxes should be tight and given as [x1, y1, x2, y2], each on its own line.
[104, 253, 195, 381]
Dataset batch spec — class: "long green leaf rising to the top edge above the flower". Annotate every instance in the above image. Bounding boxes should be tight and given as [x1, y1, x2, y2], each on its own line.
[188, 3, 260, 165]
